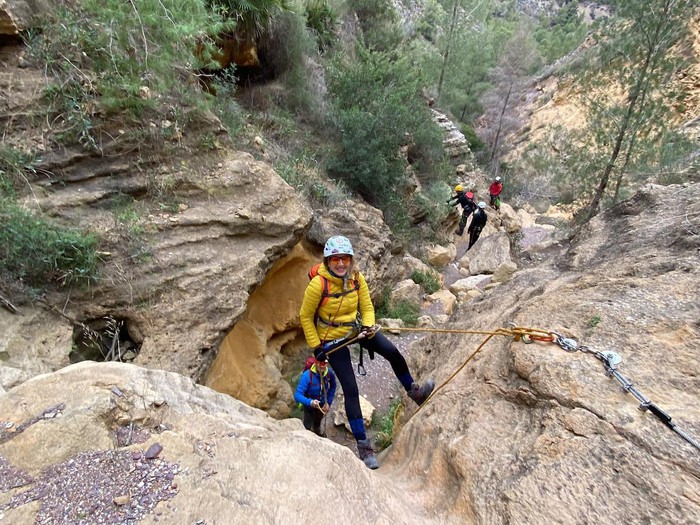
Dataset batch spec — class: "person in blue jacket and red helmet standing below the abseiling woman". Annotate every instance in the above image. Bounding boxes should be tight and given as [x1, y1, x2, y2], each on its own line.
[294, 356, 336, 437]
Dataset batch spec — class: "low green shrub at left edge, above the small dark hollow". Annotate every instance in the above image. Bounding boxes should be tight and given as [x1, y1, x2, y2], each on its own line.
[0, 199, 98, 286]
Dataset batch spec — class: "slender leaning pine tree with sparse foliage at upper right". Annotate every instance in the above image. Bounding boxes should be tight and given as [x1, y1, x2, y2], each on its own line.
[587, 0, 698, 219]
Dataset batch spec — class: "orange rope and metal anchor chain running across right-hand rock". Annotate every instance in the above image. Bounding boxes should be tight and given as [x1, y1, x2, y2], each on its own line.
[386, 323, 700, 450]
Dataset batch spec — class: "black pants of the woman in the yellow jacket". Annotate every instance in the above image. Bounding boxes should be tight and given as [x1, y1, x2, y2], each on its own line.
[328, 333, 408, 421]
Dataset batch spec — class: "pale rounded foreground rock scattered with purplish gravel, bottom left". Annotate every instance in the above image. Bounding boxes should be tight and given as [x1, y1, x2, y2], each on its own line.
[0, 363, 440, 524]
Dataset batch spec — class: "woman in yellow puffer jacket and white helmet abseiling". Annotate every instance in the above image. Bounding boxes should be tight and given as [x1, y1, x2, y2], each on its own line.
[299, 236, 435, 469]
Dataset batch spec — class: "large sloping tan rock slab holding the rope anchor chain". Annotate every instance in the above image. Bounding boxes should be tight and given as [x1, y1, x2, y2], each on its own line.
[381, 184, 700, 524]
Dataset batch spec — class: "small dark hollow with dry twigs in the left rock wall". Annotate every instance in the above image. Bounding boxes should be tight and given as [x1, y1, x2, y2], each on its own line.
[68, 315, 141, 363]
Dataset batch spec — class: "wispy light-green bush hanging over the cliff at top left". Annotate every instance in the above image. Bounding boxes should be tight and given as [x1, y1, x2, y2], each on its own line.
[29, 0, 227, 149]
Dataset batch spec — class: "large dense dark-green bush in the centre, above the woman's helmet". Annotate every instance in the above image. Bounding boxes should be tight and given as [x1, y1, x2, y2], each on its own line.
[327, 47, 444, 223]
